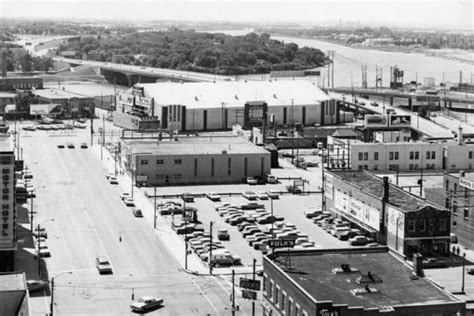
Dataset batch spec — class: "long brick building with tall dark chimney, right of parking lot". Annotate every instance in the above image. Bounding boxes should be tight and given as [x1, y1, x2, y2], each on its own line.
[324, 171, 451, 258]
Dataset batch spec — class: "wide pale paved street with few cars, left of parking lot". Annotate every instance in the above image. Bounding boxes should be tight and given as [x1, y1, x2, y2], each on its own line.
[17, 126, 246, 315]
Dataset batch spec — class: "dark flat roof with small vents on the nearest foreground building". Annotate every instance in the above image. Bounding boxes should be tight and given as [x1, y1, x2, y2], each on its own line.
[272, 247, 458, 309]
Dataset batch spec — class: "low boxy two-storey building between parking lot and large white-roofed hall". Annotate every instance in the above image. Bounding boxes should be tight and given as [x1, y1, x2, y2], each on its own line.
[120, 136, 271, 186]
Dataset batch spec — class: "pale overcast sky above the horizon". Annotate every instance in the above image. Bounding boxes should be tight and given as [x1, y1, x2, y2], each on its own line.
[0, 0, 474, 30]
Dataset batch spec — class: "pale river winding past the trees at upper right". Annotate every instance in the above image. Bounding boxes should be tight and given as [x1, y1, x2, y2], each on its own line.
[216, 29, 474, 87]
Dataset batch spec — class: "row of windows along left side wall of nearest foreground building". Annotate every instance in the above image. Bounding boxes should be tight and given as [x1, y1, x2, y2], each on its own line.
[262, 274, 308, 316]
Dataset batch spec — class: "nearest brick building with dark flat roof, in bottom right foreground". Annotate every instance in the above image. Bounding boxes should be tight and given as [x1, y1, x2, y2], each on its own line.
[262, 247, 466, 316]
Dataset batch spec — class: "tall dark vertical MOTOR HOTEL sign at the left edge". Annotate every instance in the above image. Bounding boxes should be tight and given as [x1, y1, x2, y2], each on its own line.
[0, 153, 15, 250]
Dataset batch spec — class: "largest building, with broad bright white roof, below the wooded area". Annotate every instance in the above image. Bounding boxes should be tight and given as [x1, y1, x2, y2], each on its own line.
[114, 80, 339, 131]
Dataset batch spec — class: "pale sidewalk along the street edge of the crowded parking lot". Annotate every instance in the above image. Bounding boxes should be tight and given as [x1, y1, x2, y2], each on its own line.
[90, 142, 253, 275]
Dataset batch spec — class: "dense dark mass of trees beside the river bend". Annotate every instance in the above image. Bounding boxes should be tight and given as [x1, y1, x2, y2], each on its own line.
[58, 29, 328, 75]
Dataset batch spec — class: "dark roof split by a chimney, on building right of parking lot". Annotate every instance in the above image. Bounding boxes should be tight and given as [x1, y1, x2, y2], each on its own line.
[330, 170, 439, 212]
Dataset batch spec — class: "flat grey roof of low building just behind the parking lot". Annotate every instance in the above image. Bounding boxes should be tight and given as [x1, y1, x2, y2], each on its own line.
[123, 136, 269, 155]
